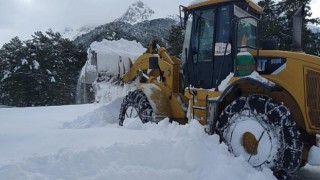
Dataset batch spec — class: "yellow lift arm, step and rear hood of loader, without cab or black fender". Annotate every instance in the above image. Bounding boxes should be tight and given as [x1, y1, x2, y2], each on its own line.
[123, 44, 320, 134]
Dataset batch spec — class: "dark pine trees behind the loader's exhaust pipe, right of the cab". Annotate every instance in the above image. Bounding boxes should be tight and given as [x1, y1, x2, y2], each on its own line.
[258, 0, 320, 56]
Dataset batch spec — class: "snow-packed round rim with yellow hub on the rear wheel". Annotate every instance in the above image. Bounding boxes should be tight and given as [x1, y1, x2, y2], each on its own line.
[224, 115, 274, 167]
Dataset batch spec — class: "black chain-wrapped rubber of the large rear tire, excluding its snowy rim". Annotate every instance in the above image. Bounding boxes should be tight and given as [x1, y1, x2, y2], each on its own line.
[216, 95, 303, 179]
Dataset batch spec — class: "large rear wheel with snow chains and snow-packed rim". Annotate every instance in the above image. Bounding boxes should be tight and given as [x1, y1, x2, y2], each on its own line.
[216, 95, 303, 179]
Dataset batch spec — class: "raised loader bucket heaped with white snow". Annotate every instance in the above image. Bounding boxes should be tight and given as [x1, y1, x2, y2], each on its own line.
[80, 39, 145, 84]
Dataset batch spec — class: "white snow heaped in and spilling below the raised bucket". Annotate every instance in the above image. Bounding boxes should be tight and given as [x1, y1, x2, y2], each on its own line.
[79, 39, 145, 103]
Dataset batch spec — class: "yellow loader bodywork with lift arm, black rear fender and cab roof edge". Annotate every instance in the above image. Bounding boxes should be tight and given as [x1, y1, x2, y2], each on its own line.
[122, 0, 320, 165]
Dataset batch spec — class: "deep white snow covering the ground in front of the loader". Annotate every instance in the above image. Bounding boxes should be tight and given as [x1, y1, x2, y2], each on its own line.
[0, 99, 316, 180]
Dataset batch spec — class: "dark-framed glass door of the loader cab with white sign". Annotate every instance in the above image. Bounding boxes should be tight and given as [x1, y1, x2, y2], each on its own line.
[186, 5, 233, 89]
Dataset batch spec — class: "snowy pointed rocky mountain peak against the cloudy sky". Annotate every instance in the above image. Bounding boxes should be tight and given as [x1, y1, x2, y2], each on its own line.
[115, 1, 155, 24]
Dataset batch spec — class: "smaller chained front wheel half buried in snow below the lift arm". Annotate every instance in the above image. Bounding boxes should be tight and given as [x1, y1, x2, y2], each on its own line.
[119, 89, 153, 126]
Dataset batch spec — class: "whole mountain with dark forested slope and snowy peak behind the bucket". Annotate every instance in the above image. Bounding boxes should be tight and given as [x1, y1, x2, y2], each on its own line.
[74, 1, 178, 47]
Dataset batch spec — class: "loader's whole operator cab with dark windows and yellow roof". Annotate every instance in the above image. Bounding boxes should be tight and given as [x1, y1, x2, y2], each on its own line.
[181, 0, 262, 89]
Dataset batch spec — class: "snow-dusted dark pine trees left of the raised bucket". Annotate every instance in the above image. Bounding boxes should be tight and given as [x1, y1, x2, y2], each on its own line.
[0, 29, 86, 106]
